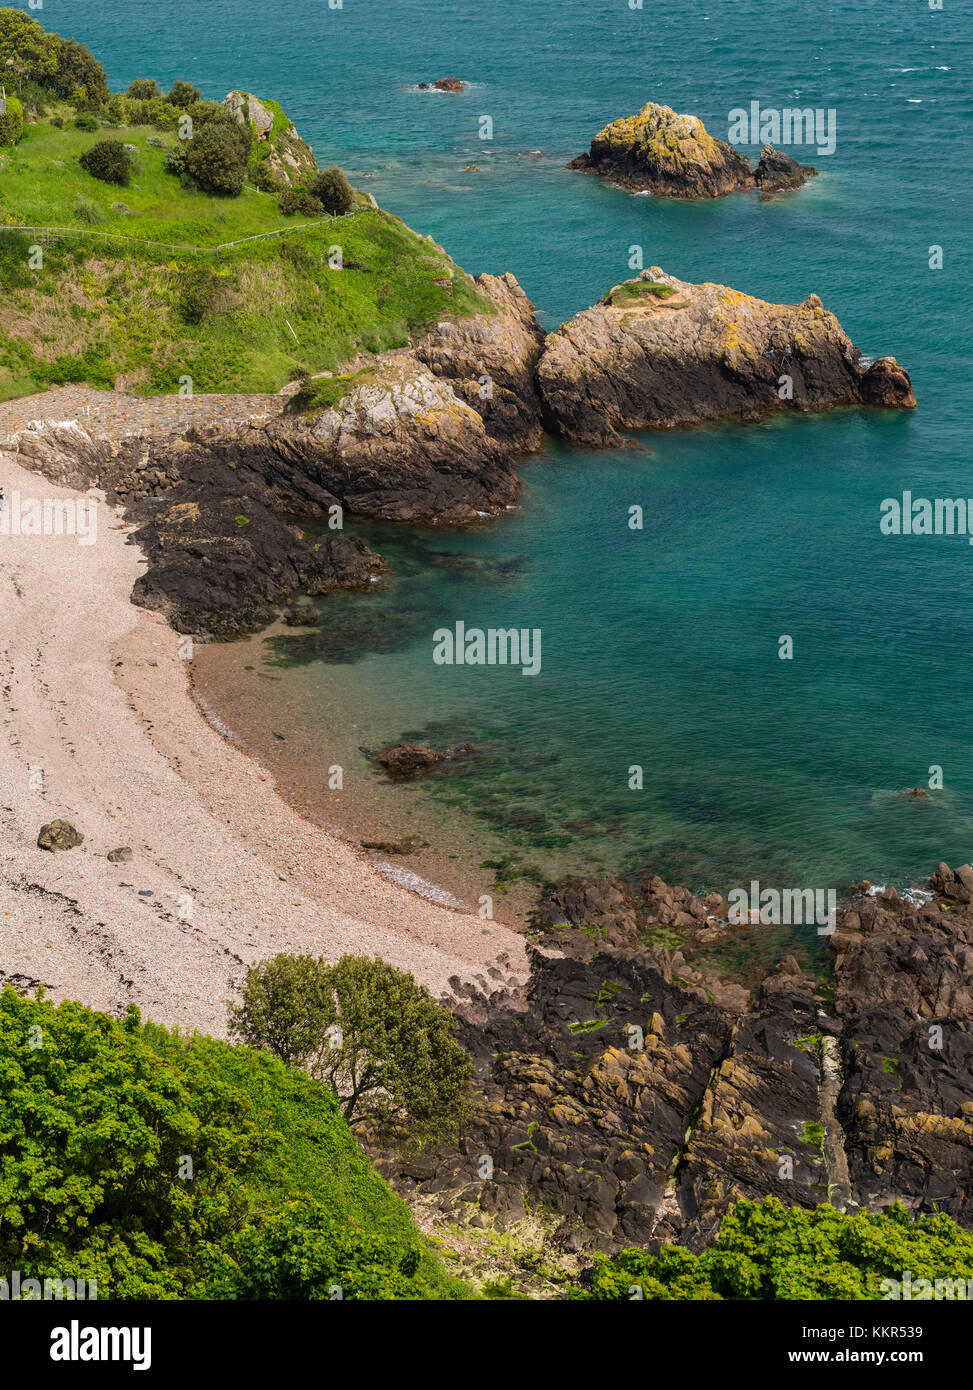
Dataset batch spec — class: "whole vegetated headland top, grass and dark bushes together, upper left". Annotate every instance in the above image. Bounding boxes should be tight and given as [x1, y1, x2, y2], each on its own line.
[0, 10, 491, 399]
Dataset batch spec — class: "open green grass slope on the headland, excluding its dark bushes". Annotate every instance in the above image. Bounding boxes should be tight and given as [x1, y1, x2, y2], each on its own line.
[0, 108, 489, 399]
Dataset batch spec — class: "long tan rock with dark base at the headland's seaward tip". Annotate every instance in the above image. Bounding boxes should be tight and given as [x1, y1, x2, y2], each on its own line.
[537, 265, 916, 445]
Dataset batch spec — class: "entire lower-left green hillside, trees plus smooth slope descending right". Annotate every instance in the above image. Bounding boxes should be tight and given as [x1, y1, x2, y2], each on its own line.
[0, 987, 466, 1298]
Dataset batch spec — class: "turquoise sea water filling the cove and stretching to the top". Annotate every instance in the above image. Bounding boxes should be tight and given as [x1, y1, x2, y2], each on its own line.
[51, 0, 973, 890]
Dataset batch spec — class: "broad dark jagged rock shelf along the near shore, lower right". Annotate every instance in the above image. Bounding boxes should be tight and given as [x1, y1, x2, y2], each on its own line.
[381, 866, 973, 1251]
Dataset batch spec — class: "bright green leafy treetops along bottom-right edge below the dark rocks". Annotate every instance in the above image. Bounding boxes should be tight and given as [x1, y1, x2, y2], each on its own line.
[571, 1197, 973, 1301]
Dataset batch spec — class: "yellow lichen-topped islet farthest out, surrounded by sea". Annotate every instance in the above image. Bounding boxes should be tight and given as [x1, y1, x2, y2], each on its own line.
[569, 101, 753, 199]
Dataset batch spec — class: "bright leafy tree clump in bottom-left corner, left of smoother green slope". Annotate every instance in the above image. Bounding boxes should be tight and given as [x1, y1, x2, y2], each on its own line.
[0, 988, 263, 1298]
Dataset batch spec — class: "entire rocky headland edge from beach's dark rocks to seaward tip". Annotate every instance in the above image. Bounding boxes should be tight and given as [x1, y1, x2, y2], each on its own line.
[0, 259, 916, 625]
